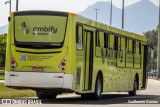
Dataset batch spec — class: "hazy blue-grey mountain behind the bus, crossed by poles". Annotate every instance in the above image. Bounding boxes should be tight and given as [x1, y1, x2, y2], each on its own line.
[79, 0, 158, 34]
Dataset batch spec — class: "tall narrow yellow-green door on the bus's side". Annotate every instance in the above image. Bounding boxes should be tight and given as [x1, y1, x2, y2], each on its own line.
[83, 30, 93, 90]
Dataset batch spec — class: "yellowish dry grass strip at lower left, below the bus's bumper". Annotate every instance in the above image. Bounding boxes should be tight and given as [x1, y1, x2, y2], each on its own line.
[0, 83, 36, 99]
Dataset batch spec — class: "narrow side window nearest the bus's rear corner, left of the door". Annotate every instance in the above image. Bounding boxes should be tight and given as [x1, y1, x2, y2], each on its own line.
[76, 26, 83, 50]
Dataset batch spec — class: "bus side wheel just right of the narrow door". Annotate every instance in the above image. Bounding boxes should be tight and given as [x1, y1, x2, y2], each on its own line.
[93, 76, 102, 99]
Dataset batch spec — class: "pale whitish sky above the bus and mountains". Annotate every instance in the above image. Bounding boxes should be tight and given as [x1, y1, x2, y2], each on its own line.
[0, 0, 159, 27]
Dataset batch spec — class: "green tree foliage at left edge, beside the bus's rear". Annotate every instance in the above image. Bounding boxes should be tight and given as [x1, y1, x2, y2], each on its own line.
[0, 34, 7, 67]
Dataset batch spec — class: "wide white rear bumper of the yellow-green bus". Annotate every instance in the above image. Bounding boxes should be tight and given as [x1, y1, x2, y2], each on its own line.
[5, 71, 73, 89]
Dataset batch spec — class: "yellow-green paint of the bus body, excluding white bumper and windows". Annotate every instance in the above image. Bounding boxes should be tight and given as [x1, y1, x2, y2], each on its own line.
[6, 13, 146, 93]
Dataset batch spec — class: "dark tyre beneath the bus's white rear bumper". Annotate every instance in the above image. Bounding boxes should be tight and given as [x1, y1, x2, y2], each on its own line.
[36, 91, 57, 99]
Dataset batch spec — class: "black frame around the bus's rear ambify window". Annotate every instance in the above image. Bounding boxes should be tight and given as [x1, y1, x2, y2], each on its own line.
[13, 11, 68, 49]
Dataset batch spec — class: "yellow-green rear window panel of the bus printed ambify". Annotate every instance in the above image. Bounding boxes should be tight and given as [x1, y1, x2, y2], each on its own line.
[15, 11, 67, 47]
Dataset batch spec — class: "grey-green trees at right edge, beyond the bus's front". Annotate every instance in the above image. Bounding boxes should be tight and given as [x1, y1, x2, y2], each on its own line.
[144, 29, 158, 69]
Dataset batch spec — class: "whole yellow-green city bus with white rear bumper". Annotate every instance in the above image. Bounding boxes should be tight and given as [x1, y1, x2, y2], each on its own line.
[5, 11, 148, 99]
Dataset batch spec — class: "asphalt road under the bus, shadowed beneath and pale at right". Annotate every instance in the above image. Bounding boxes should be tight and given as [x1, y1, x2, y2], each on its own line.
[0, 79, 160, 107]
